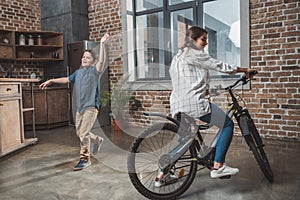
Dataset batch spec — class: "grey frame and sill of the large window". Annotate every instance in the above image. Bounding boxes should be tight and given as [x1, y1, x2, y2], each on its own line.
[121, 0, 250, 91]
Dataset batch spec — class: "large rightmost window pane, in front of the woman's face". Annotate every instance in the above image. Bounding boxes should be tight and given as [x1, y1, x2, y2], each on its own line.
[204, 0, 240, 75]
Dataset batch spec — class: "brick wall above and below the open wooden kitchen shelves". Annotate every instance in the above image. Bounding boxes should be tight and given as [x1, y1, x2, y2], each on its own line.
[0, 0, 43, 78]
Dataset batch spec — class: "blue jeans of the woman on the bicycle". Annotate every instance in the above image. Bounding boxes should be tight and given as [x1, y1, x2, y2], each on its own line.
[200, 103, 234, 163]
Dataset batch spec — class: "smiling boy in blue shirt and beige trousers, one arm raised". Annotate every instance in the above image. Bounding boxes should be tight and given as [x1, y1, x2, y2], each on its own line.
[40, 34, 109, 171]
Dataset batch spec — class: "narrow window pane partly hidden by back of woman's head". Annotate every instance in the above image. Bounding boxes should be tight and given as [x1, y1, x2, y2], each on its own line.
[171, 8, 194, 57]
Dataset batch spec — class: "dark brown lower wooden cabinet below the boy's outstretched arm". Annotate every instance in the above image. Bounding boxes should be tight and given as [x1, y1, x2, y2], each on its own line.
[23, 87, 69, 130]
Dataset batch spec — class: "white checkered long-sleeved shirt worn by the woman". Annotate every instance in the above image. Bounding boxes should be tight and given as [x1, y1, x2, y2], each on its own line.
[169, 47, 237, 118]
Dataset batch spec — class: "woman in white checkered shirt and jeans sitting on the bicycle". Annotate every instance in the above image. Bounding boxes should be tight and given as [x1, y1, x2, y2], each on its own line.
[155, 26, 254, 186]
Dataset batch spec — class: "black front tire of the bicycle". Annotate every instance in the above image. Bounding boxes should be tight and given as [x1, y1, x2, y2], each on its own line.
[244, 118, 273, 183]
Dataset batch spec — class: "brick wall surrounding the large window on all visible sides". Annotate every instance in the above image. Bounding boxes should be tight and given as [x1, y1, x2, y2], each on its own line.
[89, 0, 300, 139]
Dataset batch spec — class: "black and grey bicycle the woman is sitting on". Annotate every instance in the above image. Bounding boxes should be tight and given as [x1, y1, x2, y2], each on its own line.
[127, 72, 273, 199]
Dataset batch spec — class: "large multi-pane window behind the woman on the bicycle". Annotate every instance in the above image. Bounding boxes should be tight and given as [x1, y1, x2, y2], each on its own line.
[126, 0, 249, 89]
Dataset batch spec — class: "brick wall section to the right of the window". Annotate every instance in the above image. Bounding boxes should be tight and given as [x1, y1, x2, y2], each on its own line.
[249, 0, 300, 139]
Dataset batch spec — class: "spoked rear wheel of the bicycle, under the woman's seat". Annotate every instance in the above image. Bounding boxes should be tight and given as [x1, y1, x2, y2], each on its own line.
[127, 123, 197, 200]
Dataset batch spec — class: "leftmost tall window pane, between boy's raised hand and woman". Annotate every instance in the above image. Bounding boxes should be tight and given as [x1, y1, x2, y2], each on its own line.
[136, 12, 167, 79]
